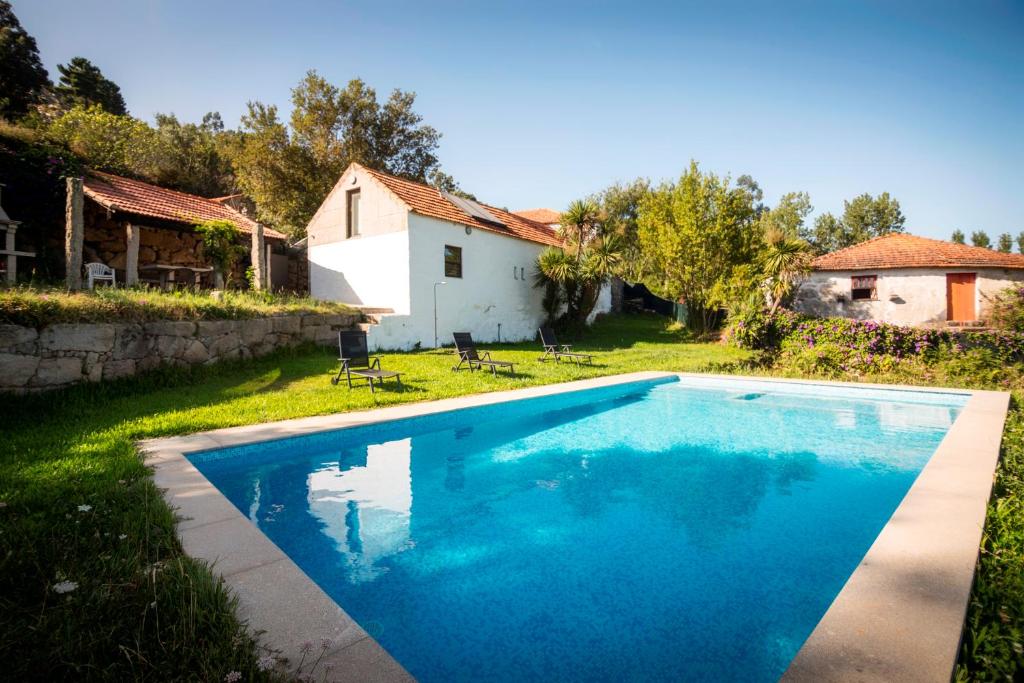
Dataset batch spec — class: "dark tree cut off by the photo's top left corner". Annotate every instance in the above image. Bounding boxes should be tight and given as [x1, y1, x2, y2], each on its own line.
[0, 0, 50, 119]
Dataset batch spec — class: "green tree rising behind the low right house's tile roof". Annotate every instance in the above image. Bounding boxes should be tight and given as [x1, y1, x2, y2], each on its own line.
[802, 193, 906, 253]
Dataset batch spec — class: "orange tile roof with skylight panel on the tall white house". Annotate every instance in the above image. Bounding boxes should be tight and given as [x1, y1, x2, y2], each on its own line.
[353, 164, 562, 247]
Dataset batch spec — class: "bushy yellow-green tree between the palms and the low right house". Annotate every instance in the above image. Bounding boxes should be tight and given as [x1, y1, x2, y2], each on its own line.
[637, 162, 761, 332]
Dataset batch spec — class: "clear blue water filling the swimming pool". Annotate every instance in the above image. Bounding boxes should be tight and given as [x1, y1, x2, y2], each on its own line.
[191, 378, 967, 681]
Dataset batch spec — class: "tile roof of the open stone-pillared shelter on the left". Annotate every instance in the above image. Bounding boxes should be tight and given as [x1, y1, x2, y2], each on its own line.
[83, 171, 285, 240]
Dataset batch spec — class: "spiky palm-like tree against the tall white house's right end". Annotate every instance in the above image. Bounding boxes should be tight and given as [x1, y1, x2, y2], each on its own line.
[537, 200, 623, 327]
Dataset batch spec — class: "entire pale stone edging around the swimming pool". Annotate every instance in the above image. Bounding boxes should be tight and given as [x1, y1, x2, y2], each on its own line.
[139, 372, 1010, 681]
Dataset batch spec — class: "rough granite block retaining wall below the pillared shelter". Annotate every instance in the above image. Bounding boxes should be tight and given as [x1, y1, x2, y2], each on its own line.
[0, 313, 361, 392]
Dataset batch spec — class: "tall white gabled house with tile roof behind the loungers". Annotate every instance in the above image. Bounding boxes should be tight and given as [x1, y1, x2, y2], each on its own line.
[307, 164, 611, 349]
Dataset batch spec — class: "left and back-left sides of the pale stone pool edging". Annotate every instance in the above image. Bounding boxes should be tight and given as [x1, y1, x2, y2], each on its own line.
[136, 372, 677, 681]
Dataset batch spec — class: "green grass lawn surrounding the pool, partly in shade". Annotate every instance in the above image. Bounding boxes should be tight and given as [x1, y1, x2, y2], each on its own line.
[0, 316, 1024, 681]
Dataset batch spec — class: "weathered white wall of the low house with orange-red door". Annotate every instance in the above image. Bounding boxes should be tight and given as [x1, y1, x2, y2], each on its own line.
[794, 268, 1024, 327]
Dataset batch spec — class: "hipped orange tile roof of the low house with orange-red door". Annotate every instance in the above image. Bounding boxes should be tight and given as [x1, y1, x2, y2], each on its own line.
[813, 232, 1024, 270]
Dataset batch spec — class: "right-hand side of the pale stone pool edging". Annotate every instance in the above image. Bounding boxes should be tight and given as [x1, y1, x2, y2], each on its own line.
[770, 385, 1010, 683]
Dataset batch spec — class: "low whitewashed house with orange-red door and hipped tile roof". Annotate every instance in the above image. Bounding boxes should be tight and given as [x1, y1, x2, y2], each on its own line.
[794, 233, 1024, 327]
